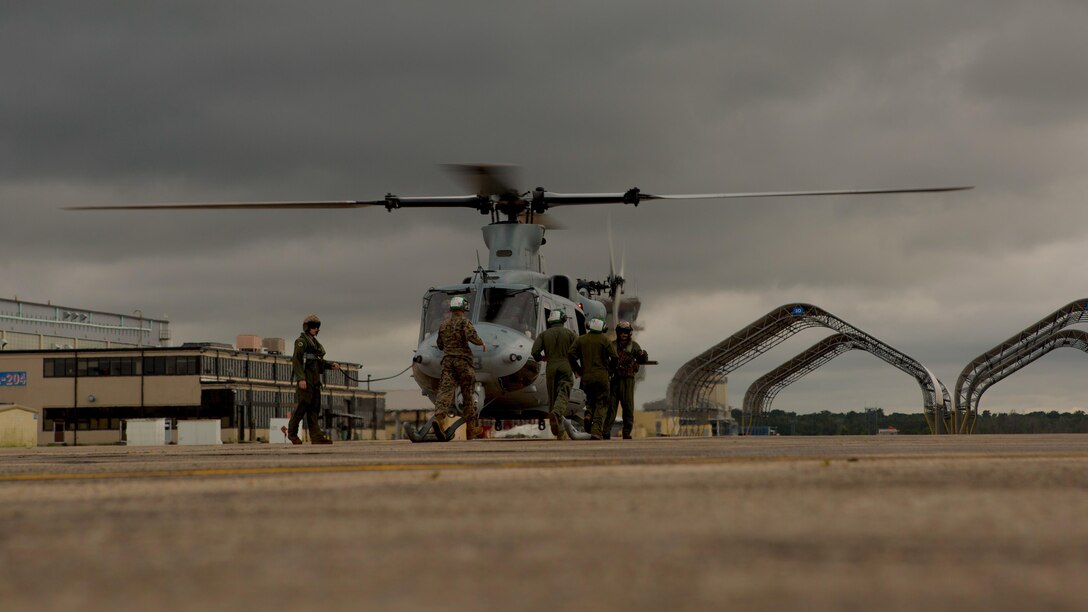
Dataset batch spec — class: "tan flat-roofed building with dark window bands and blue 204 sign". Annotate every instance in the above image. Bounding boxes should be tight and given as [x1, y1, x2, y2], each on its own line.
[0, 343, 385, 444]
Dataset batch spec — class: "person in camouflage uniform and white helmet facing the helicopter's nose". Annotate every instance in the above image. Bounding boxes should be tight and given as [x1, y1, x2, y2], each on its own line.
[434, 296, 487, 440]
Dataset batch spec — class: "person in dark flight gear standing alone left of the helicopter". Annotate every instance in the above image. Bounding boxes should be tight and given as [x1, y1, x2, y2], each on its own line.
[286, 315, 339, 444]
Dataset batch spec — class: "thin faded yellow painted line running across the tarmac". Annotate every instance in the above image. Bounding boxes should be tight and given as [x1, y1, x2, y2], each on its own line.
[0, 452, 1088, 482]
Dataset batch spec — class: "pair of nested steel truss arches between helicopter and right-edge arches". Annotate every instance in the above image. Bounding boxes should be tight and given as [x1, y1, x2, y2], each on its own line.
[667, 303, 956, 433]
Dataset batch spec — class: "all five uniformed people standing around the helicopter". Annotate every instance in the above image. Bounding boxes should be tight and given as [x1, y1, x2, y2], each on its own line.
[284, 296, 647, 444]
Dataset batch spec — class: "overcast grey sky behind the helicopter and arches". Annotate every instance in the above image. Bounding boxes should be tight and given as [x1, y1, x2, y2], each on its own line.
[0, 0, 1088, 412]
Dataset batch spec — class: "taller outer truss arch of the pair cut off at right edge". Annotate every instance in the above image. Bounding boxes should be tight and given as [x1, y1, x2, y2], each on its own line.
[955, 298, 1088, 433]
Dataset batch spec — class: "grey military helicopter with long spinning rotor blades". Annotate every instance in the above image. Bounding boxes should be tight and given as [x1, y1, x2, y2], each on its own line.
[70, 164, 973, 441]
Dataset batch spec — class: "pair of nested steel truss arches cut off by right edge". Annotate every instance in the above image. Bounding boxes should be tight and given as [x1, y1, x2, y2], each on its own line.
[955, 298, 1088, 433]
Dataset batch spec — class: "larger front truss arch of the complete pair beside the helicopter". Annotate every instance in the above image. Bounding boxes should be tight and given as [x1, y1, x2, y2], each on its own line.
[667, 303, 957, 433]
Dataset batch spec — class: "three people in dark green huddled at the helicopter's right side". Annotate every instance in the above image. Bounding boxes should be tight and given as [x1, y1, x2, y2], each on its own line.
[532, 309, 647, 440]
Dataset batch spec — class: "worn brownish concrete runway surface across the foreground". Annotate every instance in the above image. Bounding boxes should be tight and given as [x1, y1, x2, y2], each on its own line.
[0, 436, 1088, 612]
